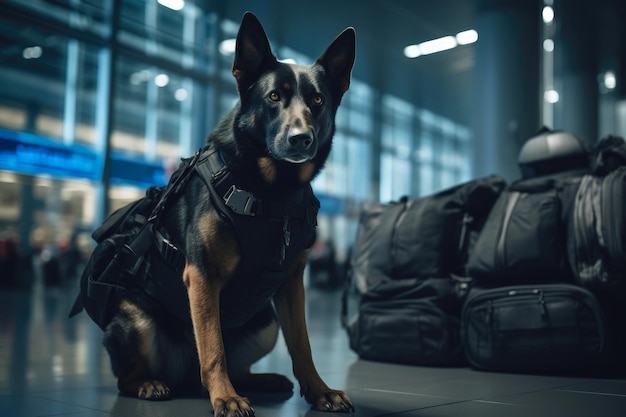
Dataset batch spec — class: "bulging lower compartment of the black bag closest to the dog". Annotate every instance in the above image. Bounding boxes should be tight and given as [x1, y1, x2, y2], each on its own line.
[348, 278, 465, 366]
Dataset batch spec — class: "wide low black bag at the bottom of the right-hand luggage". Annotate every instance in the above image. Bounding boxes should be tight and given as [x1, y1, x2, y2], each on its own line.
[461, 284, 608, 372]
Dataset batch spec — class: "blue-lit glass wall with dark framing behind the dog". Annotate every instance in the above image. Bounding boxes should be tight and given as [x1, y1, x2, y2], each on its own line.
[0, 0, 472, 284]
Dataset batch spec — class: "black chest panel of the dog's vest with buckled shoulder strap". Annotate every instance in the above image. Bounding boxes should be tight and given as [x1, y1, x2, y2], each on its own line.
[190, 148, 320, 327]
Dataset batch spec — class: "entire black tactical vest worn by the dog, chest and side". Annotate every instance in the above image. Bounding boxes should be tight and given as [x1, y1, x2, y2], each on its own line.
[70, 148, 319, 329]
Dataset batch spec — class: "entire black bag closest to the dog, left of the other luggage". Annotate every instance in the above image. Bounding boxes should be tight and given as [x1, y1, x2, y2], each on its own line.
[342, 176, 505, 365]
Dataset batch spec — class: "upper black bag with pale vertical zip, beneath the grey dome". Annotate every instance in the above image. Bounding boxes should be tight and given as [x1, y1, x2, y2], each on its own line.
[467, 173, 582, 286]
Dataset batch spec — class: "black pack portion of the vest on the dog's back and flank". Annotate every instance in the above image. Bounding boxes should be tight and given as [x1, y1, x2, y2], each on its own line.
[70, 151, 201, 330]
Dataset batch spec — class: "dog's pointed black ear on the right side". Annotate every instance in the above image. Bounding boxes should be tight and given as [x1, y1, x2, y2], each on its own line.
[316, 27, 356, 98]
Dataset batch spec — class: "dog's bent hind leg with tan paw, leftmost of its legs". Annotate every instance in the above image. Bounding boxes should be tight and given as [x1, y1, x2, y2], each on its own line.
[104, 300, 170, 400]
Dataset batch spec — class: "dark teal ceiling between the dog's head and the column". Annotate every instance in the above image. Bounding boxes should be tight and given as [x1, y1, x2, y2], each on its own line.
[214, 0, 478, 123]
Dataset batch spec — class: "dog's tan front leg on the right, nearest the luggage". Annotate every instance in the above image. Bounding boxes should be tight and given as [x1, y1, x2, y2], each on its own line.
[274, 251, 354, 412]
